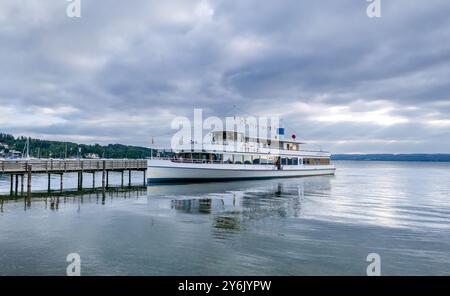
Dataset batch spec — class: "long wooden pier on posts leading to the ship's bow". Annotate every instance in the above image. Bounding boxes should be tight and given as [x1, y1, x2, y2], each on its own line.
[0, 159, 147, 196]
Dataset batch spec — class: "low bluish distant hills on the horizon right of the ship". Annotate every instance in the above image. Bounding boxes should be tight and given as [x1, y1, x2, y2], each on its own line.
[332, 154, 450, 162]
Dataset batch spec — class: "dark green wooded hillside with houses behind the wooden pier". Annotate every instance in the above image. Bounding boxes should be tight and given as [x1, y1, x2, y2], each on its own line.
[0, 133, 155, 159]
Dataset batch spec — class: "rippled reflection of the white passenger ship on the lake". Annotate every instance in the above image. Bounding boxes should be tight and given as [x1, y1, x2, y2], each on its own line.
[160, 177, 314, 238]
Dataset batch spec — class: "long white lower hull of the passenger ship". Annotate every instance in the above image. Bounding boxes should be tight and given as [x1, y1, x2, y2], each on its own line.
[147, 159, 336, 183]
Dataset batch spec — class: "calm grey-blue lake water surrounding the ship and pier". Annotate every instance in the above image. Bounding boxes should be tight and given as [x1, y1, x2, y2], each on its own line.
[0, 162, 450, 275]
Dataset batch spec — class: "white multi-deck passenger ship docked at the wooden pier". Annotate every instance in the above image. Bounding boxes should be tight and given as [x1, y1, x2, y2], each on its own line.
[147, 125, 336, 183]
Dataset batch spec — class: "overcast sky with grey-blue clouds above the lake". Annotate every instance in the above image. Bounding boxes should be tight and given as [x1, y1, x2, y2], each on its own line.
[0, 0, 450, 153]
